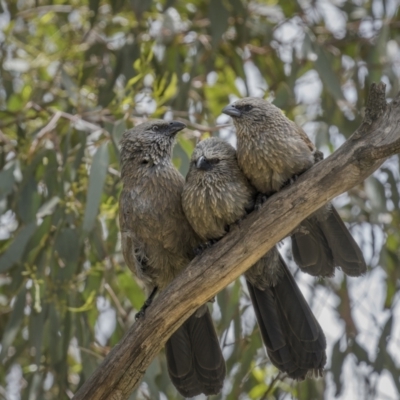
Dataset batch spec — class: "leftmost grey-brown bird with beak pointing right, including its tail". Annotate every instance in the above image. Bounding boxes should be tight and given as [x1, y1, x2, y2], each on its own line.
[119, 120, 225, 397]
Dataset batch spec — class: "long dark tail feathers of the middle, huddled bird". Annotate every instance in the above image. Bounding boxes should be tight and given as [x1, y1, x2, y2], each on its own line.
[247, 257, 326, 380]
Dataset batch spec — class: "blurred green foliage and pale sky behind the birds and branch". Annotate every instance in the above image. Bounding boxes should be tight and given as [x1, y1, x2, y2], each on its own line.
[0, 0, 400, 400]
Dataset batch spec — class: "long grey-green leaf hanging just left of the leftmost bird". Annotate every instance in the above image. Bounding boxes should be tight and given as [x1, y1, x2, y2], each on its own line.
[83, 143, 108, 232]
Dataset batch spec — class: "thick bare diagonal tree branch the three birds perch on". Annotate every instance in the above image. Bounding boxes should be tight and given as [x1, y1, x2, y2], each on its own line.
[74, 84, 400, 400]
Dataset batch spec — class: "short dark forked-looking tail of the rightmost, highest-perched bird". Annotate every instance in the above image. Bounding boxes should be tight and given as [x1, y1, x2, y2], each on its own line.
[292, 207, 367, 276]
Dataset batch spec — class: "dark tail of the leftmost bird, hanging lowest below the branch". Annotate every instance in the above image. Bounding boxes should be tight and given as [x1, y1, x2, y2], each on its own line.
[165, 309, 226, 397]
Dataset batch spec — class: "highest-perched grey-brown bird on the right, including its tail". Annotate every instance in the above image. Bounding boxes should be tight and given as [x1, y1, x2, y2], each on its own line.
[222, 97, 366, 276]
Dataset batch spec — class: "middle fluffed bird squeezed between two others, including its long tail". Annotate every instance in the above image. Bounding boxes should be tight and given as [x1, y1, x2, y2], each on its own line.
[182, 138, 326, 380]
